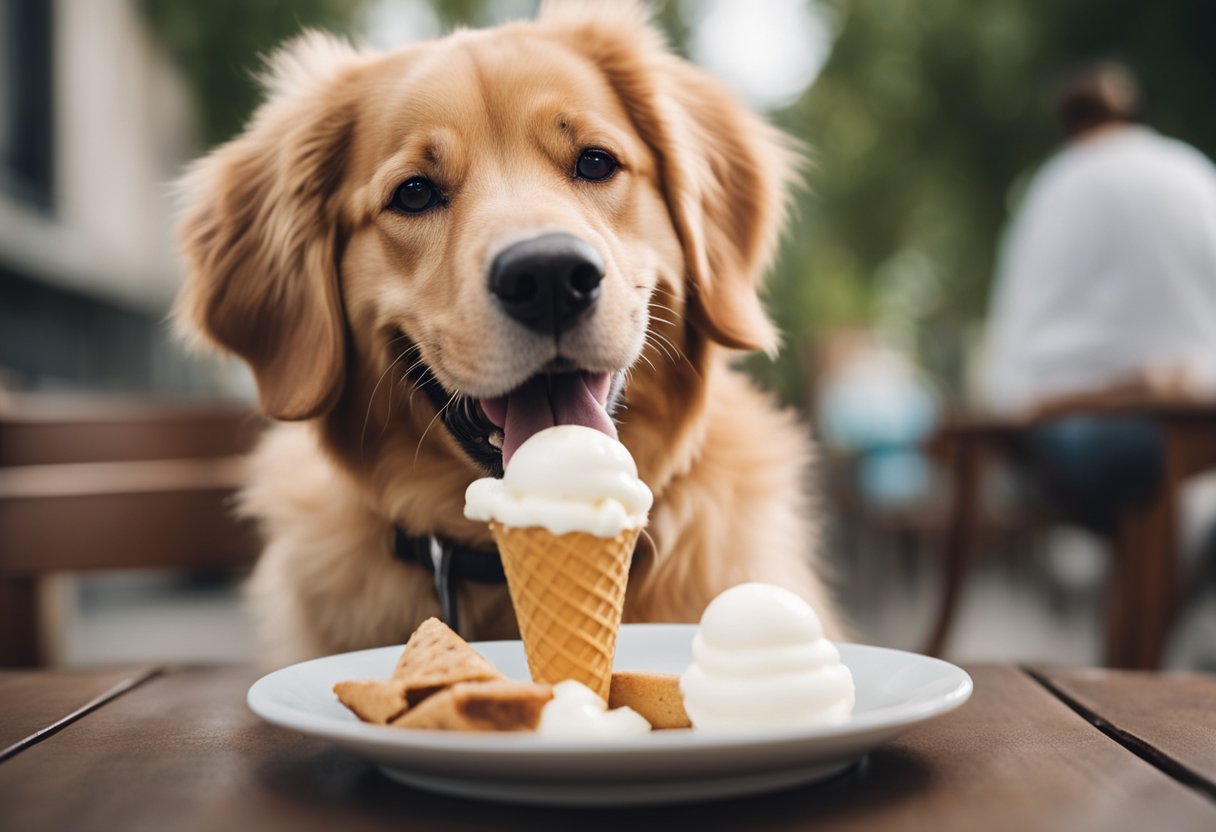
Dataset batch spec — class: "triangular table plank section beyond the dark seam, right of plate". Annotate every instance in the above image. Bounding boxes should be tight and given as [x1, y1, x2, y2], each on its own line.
[1036, 668, 1216, 797]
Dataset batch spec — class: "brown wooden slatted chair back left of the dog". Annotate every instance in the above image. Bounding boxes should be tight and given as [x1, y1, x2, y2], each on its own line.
[0, 397, 263, 667]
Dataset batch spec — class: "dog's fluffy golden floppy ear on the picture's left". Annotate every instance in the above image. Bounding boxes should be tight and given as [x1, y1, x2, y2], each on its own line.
[175, 32, 360, 420]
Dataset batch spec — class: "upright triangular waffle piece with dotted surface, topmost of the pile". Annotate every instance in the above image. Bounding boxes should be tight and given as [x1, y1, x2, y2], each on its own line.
[393, 618, 503, 707]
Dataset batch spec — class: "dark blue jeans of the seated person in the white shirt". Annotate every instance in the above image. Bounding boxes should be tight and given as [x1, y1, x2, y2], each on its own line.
[1028, 416, 1165, 535]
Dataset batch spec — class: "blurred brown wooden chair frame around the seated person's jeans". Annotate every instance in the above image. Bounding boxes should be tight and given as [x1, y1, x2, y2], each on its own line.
[925, 395, 1216, 669]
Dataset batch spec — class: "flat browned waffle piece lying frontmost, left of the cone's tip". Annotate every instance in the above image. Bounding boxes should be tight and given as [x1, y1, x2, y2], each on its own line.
[392, 679, 553, 731]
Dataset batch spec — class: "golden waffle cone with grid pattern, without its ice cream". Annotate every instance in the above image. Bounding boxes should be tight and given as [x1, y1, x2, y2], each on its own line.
[490, 523, 641, 702]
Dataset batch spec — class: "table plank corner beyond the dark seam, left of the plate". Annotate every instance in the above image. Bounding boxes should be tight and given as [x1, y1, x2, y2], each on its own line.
[0, 668, 156, 751]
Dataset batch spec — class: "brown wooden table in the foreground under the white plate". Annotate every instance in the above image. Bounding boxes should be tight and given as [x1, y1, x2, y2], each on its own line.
[0, 665, 1216, 832]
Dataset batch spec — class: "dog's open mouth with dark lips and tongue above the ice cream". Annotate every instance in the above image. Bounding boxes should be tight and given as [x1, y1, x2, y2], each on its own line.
[409, 362, 621, 477]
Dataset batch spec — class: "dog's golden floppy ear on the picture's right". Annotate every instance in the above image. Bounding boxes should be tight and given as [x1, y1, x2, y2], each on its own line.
[541, 0, 798, 354]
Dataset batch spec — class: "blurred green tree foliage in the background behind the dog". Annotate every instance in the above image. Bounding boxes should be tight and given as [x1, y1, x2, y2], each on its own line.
[140, 0, 1216, 403]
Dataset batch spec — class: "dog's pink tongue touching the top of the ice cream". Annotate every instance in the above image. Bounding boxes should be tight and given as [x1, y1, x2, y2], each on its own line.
[482, 372, 617, 467]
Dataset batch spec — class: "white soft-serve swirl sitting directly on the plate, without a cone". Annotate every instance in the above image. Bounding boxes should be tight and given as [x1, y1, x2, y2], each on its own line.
[680, 584, 854, 731]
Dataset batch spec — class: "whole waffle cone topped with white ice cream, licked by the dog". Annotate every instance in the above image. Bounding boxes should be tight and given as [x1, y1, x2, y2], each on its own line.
[465, 425, 654, 702]
